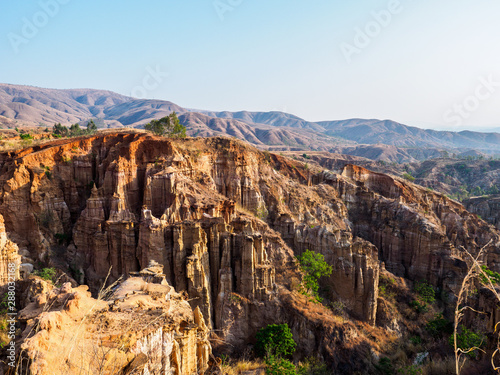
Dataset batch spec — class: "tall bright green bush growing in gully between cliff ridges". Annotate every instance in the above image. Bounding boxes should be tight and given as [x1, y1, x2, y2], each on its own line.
[297, 250, 332, 302]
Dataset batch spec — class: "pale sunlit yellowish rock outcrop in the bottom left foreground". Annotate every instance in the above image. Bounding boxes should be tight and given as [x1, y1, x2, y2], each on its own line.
[19, 265, 212, 375]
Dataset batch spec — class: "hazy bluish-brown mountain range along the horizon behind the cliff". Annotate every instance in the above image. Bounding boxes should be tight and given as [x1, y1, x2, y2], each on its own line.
[0, 84, 500, 162]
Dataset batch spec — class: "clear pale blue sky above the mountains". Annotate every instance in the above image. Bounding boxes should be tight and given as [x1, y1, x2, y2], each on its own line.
[0, 0, 500, 130]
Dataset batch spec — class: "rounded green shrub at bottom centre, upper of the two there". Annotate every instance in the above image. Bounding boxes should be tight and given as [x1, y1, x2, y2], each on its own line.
[254, 324, 297, 357]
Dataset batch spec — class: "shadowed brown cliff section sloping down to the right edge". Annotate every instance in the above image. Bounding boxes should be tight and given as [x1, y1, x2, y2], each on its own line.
[322, 165, 500, 292]
